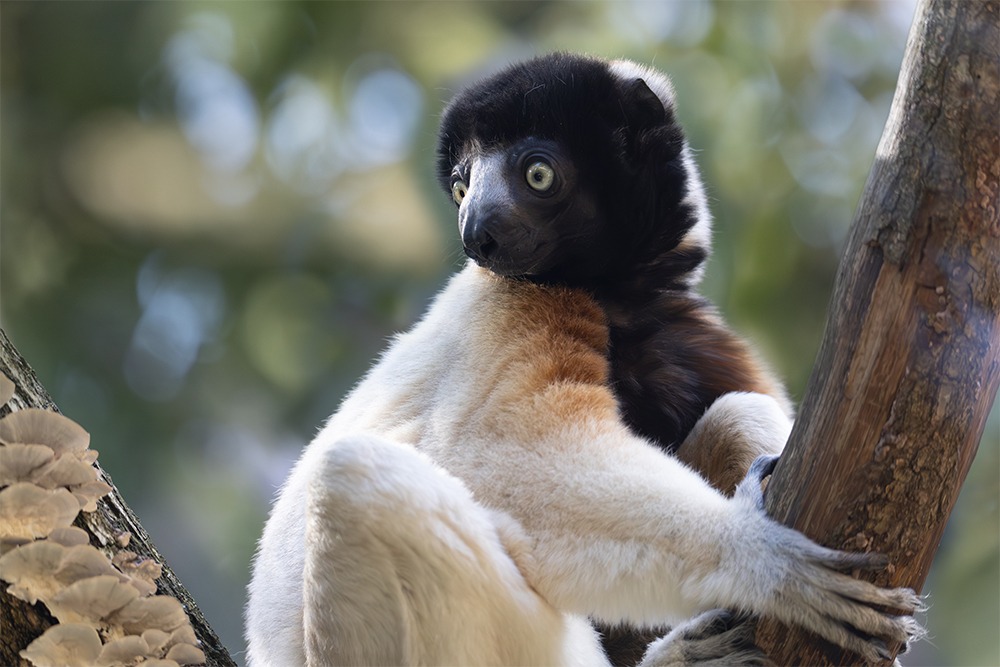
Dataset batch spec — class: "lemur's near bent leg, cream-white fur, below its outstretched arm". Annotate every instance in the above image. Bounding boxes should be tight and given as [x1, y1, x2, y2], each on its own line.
[303, 436, 603, 666]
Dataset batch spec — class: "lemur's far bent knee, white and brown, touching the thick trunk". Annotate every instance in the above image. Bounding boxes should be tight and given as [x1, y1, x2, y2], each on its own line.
[675, 392, 792, 496]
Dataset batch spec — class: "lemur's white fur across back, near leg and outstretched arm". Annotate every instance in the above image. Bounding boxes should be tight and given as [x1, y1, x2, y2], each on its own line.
[247, 265, 910, 667]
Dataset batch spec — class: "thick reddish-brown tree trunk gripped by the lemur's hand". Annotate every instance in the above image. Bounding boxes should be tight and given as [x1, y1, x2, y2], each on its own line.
[757, 0, 1000, 665]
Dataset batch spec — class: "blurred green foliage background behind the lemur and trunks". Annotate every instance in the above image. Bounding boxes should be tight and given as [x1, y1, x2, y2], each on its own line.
[0, 0, 1000, 665]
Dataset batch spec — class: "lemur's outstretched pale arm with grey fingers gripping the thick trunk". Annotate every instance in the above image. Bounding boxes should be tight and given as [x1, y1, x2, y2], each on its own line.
[470, 394, 919, 661]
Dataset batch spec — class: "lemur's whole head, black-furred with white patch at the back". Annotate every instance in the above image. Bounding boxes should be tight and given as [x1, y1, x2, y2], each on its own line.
[438, 53, 710, 287]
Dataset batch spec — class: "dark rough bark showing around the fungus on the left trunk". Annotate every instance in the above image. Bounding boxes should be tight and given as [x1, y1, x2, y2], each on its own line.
[0, 329, 236, 667]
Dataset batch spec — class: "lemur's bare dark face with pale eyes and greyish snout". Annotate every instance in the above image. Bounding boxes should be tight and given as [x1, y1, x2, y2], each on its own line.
[451, 137, 602, 278]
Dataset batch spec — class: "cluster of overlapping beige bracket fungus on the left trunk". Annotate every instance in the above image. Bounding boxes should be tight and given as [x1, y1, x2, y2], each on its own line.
[0, 373, 205, 667]
